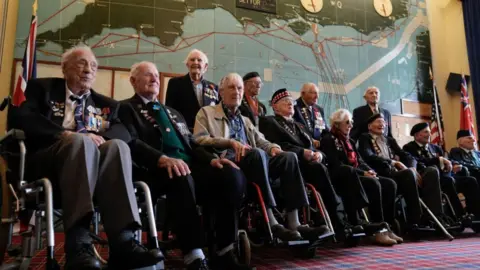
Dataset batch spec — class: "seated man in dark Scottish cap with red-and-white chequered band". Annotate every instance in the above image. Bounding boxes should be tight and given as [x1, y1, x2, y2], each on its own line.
[259, 89, 346, 234]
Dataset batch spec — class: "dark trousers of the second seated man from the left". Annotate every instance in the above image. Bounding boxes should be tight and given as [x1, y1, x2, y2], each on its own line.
[145, 168, 204, 254]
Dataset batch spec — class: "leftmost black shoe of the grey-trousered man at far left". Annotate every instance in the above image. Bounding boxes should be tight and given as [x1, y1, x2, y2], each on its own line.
[65, 244, 102, 270]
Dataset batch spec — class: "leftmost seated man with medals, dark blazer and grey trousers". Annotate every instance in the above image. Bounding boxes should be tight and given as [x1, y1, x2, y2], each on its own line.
[6, 47, 163, 269]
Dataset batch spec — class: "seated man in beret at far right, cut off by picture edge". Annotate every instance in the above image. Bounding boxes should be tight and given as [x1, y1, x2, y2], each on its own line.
[450, 130, 480, 220]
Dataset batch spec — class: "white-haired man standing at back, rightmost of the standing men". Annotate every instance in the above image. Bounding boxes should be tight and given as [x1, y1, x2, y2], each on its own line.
[350, 86, 392, 141]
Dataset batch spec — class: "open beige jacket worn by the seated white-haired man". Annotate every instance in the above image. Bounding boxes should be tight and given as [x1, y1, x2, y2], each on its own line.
[193, 103, 280, 154]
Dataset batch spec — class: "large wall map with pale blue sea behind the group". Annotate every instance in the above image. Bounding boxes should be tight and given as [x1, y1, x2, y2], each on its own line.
[15, 0, 431, 117]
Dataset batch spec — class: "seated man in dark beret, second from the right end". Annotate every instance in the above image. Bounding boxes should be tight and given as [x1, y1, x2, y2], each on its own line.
[403, 122, 476, 224]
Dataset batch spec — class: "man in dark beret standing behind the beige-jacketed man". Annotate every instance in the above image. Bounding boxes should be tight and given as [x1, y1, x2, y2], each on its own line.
[239, 71, 267, 127]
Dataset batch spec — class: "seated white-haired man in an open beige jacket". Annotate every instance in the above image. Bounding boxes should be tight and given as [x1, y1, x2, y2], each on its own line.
[194, 73, 329, 241]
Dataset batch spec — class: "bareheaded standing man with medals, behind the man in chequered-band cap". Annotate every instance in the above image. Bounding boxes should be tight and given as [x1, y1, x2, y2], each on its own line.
[293, 83, 328, 148]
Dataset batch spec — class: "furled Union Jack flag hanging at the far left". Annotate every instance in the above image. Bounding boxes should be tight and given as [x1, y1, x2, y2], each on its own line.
[12, 0, 37, 106]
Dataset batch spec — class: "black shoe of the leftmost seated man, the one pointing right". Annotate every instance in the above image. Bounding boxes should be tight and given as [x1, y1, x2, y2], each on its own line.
[108, 238, 165, 270]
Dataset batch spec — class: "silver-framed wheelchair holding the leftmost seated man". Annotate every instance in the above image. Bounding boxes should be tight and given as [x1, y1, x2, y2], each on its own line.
[0, 97, 164, 270]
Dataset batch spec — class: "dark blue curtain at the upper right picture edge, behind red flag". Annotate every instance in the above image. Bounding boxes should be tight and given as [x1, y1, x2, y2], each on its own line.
[462, 0, 480, 134]
